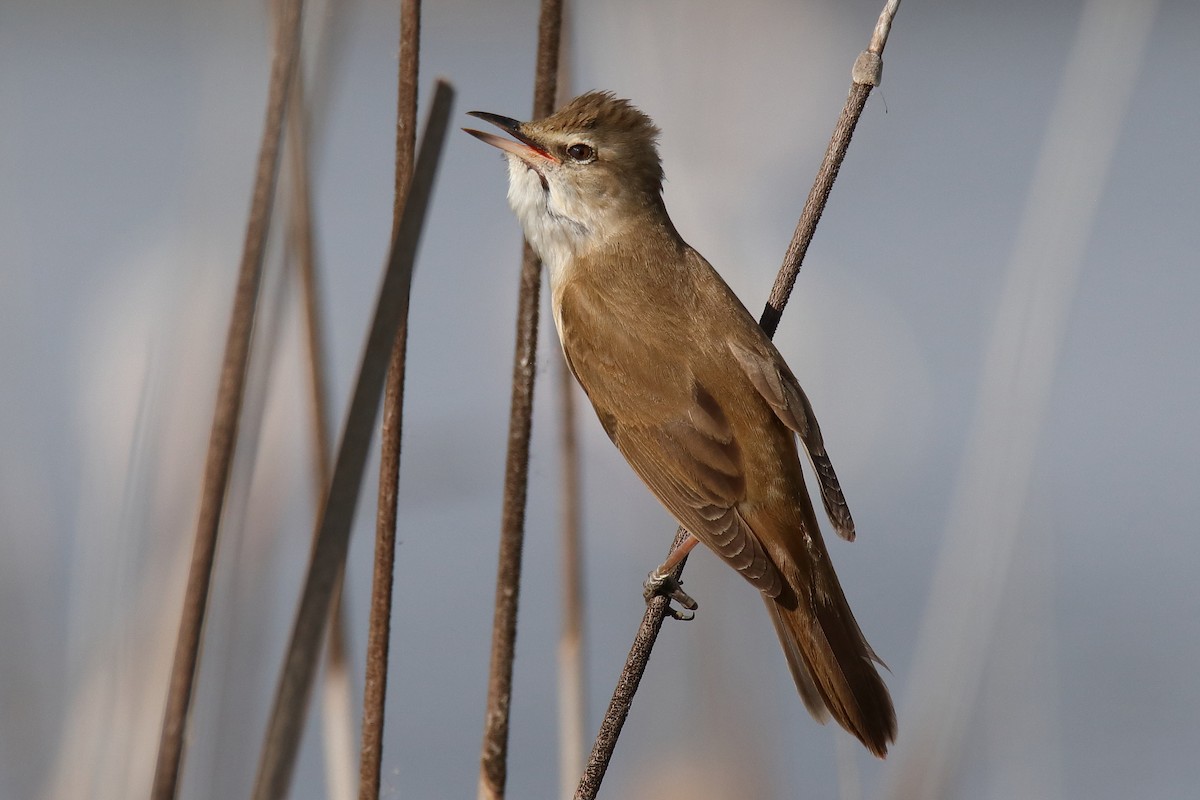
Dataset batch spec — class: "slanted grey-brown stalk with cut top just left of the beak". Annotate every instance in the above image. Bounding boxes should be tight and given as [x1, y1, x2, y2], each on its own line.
[252, 82, 454, 800]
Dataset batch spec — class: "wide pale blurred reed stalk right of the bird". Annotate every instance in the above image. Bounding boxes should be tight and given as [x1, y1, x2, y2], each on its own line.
[887, 0, 1157, 800]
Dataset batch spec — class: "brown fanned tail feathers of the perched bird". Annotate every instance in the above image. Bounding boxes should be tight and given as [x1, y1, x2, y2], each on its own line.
[764, 584, 896, 758]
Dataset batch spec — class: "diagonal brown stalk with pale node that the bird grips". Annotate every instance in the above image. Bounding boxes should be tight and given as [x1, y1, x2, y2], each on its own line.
[575, 0, 900, 800]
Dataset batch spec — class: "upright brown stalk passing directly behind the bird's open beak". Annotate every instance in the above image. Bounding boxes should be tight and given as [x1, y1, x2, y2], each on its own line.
[479, 0, 563, 800]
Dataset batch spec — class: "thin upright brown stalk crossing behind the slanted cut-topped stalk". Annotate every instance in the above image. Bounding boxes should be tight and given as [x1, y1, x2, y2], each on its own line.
[359, 0, 421, 800]
